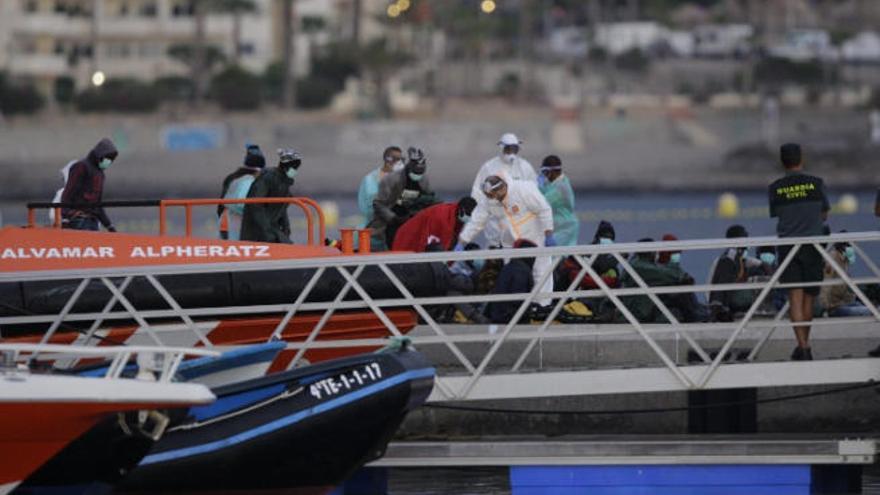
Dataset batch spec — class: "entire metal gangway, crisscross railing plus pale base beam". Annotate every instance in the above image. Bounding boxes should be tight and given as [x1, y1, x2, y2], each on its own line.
[0, 232, 880, 401]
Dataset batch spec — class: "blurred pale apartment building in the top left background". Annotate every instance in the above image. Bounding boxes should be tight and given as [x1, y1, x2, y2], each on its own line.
[0, 0, 387, 96]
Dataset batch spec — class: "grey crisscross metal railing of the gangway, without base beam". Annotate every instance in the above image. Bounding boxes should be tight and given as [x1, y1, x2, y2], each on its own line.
[0, 232, 880, 399]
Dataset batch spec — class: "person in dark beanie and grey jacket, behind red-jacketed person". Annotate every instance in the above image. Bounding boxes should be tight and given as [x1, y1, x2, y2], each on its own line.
[369, 148, 435, 251]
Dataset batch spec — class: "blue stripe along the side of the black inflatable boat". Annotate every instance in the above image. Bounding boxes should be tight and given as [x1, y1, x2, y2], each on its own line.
[139, 368, 436, 466]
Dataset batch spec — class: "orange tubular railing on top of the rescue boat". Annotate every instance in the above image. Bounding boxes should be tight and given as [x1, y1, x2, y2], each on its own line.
[27, 197, 327, 246]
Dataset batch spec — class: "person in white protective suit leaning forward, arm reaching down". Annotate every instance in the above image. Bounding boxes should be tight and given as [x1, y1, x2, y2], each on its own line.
[455, 175, 556, 306]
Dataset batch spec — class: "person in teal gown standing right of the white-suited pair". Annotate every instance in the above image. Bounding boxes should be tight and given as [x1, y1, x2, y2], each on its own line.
[538, 155, 580, 246]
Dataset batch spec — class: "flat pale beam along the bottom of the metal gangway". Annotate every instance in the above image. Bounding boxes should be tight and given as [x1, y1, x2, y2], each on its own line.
[428, 358, 880, 402]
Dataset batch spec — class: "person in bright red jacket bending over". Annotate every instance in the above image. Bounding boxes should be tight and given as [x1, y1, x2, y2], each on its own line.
[392, 196, 477, 252]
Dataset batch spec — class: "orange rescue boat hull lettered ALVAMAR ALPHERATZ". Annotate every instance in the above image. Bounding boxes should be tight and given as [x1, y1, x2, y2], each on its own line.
[0, 227, 447, 371]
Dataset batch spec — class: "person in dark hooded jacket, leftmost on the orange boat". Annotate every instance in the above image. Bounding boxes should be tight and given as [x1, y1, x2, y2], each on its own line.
[61, 138, 119, 232]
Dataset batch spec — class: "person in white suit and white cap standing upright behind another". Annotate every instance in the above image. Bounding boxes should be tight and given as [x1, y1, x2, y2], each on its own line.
[471, 132, 538, 246]
